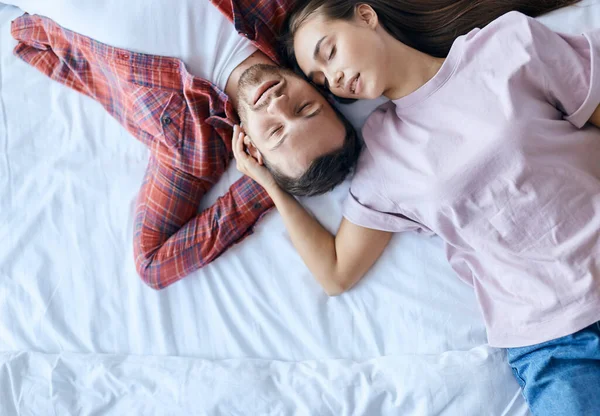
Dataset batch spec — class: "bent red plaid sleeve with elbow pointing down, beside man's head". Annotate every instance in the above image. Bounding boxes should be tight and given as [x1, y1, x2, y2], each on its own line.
[134, 158, 273, 289]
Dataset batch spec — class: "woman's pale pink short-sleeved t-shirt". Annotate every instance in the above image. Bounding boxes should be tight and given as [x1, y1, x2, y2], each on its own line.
[344, 12, 600, 347]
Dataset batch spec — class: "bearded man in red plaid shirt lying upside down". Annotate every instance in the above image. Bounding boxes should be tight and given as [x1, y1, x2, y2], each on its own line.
[12, 0, 359, 289]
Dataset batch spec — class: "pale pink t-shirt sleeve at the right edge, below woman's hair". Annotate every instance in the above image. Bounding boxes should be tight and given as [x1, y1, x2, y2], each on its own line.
[522, 12, 600, 127]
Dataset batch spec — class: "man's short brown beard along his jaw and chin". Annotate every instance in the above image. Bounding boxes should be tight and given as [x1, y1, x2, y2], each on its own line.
[237, 64, 295, 123]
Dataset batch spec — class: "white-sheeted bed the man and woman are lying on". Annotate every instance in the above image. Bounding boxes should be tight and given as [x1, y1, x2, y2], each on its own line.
[0, 0, 600, 416]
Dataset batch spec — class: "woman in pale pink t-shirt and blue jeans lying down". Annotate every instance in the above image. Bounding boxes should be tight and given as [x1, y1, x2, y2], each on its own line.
[234, 0, 600, 415]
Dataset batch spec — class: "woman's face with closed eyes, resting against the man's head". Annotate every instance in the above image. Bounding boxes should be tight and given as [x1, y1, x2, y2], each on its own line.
[294, 5, 391, 99]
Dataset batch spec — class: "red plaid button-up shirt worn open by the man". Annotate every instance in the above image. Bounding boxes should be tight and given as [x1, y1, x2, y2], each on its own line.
[12, 0, 293, 289]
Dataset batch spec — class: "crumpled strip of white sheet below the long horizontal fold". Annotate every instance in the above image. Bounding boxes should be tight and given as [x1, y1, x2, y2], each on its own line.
[0, 346, 524, 416]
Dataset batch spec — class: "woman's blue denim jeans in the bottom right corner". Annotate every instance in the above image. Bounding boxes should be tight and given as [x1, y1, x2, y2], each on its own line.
[507, 322, 600, 416]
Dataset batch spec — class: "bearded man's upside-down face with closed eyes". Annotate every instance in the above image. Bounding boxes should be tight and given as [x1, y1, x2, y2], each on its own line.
[238, 64, 346, 178]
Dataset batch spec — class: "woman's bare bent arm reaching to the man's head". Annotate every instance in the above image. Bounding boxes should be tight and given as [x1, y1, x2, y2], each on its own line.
[233, 126, 392, 296]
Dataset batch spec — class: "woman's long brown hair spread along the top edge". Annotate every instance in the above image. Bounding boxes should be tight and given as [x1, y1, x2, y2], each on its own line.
[282, 0, 579, 61]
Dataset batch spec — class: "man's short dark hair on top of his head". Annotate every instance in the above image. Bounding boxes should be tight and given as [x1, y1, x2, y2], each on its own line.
[264, 106, 362, 196]
